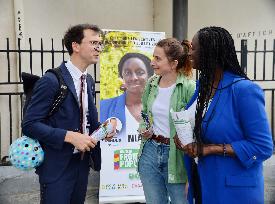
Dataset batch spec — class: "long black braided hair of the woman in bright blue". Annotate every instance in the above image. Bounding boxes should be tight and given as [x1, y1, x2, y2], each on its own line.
[194, 27, 248, 155]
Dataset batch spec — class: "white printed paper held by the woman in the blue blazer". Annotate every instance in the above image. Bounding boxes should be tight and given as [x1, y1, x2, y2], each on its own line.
[170, 109, 193, 145]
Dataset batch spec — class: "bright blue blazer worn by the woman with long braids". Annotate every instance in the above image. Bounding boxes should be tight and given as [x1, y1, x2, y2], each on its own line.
[184, 72, 273, 204]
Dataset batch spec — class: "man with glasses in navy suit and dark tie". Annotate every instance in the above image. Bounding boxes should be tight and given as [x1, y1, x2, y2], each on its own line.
[22, 24, 113, 204]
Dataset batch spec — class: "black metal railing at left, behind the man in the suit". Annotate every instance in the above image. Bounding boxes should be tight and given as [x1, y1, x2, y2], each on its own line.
[0, 38, 100, 165]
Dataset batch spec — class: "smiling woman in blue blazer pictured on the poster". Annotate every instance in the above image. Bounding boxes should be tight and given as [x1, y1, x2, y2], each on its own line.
[100, 53, 154, 129]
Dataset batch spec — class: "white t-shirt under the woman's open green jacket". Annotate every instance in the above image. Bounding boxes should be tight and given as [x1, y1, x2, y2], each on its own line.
[152, 84, 176, 138]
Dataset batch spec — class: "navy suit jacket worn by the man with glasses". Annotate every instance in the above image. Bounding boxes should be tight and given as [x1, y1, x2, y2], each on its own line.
[22, 62, 101, 184]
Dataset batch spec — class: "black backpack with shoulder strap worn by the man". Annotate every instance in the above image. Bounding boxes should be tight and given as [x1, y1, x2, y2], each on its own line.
[22, 67, 68, 117]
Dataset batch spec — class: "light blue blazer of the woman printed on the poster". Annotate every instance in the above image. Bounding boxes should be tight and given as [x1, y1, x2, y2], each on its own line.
[100, 92, 126, 129]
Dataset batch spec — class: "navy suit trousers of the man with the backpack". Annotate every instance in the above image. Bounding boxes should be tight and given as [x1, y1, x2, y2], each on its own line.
[40, 153, 90, 204]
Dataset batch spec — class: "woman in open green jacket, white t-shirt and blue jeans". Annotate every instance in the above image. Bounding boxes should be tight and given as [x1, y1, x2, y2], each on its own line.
[138, 38, 195, 204]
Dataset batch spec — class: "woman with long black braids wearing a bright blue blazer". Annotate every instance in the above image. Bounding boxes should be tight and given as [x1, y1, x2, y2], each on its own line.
[175, 27, 273, 204]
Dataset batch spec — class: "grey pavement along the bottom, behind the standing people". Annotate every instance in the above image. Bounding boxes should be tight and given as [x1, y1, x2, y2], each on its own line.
[0, 155, 275, 204]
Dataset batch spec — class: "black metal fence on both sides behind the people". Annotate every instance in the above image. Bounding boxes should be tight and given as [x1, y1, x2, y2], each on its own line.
[0, 38, 275, 165]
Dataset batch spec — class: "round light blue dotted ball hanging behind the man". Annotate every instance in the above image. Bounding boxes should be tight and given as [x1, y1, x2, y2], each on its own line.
[9, 136, 44, 171]
